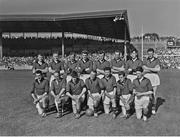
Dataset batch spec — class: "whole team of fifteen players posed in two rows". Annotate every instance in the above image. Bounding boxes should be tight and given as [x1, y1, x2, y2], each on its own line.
[31, 48, 160, 121]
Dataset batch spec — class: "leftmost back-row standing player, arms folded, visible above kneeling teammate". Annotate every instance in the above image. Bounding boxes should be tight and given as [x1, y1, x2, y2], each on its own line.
[32, 54, 48, 76]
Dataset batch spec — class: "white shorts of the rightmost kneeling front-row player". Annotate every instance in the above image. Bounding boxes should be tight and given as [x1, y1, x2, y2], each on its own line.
[134, 96, 149, 109]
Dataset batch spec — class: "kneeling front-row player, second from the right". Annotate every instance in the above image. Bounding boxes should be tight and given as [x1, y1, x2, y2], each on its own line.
[117, 71, 134, 118]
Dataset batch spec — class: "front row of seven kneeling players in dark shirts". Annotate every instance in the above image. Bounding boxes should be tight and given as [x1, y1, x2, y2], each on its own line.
[31, 67, 153, 121]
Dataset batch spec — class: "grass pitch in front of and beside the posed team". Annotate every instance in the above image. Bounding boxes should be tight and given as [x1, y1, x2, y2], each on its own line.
[0, 70, 180, 136]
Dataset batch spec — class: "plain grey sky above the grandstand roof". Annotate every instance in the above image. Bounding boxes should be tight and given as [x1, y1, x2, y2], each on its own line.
[0, 0, 180, 38]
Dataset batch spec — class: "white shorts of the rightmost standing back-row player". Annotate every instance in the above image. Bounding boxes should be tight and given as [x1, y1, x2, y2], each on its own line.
[144, 73, 160, 87]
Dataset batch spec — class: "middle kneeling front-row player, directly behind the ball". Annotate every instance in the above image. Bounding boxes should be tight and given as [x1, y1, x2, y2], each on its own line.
[85, 71, 103, 117]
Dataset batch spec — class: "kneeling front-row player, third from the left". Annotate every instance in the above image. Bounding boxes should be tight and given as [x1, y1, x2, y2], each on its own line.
[66, 71, 86, 119]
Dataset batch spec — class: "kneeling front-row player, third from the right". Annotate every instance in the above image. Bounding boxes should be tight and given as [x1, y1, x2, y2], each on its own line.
[102, 67, 116, 118]
